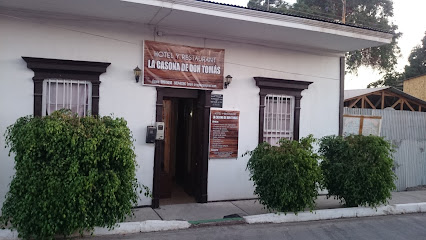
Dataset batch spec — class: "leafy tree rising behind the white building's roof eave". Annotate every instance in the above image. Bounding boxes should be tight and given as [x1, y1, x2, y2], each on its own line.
[248, 0, 401, 73]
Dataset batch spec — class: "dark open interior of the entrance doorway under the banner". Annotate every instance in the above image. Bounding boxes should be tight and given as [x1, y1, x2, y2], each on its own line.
[160, 98, 196, 205]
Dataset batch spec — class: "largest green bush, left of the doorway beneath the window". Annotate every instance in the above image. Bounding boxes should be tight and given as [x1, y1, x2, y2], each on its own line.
[1, 110, 142, 239]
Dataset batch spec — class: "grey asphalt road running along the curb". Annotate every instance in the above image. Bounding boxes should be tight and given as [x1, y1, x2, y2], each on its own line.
[86, 214, 426, 240]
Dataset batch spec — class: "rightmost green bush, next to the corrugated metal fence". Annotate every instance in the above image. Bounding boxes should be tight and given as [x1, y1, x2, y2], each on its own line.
[319, 135, 396, 207]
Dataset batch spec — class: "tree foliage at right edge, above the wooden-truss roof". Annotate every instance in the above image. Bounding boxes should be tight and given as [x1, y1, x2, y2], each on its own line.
[367, 32, 426, 90]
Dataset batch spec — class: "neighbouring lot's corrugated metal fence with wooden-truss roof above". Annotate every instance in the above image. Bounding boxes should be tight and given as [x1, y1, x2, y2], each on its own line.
[344, 87, 426, 191]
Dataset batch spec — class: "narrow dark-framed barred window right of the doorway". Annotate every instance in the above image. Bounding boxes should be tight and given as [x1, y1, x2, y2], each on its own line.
[254, 77, 312, 142]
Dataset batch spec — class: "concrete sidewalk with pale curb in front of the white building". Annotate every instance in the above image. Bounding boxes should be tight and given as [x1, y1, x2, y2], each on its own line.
[0, 190, 426, 240]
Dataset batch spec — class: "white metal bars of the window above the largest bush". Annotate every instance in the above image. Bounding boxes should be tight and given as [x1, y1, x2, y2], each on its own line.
[42, 79, 92, 116]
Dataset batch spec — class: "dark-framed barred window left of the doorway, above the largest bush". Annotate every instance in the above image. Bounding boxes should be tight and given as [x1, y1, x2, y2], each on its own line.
[22, 57, 111, 116]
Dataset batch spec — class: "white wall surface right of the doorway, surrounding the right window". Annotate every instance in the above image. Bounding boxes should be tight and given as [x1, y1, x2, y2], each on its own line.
[207, 42, 339, 201]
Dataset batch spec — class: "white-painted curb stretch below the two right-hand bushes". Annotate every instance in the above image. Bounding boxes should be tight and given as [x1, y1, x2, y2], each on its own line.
[243, 202, 426, 224]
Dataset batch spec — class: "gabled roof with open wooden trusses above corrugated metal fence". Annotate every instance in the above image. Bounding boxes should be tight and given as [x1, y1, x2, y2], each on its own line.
[344, 87, 426, 112]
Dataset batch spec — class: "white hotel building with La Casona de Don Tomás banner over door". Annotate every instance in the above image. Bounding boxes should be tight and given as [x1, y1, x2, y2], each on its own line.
[0, 0, 392, 207]
